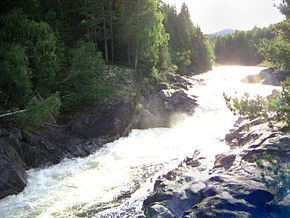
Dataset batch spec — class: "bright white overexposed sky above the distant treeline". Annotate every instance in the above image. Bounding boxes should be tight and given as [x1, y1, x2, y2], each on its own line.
[163, 0, 284, 34]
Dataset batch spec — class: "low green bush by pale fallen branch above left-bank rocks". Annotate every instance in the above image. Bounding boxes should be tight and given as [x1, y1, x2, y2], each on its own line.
[15, 94, 61, 130]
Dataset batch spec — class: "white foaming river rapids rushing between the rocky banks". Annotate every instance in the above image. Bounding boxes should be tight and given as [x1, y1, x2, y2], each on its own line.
[0, 66, 280, 218]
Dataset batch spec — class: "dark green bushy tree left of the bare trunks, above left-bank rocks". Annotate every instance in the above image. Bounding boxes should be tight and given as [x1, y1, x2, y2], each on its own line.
[63, 41, 108, 111]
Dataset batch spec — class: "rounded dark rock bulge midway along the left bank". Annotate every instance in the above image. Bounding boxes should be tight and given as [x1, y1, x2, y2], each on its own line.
[68, 97, 137, 139]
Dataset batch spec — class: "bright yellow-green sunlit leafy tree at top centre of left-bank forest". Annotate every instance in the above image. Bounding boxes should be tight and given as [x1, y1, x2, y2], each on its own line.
[117, 0, 168, 70]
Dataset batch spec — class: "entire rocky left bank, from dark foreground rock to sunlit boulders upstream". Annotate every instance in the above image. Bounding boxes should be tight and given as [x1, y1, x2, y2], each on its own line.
[0, 71, 197, 199]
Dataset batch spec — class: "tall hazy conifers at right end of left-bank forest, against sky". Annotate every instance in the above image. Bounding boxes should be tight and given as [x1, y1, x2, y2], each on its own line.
[163, 4, 214, 75]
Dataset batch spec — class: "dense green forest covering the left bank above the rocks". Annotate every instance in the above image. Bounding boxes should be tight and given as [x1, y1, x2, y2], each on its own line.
[0, 0, 213, 129]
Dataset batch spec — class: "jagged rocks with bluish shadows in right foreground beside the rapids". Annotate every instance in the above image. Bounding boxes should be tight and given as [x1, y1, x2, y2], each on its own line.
[143, 119, 290, 217]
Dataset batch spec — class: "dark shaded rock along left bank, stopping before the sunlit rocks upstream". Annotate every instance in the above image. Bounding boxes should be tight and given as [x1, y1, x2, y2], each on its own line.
[0, 98, 139, 198]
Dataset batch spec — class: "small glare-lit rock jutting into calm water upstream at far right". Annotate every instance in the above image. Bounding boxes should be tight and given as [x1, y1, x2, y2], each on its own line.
[243, 68, 290, 86]
